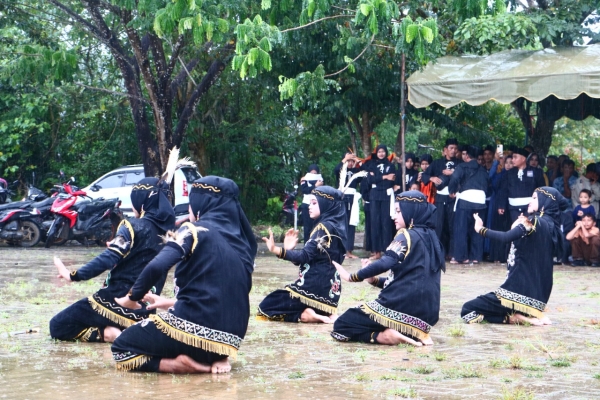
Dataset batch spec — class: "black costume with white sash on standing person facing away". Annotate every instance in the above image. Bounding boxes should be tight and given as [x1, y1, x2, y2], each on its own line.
[448, 159, 488, 262]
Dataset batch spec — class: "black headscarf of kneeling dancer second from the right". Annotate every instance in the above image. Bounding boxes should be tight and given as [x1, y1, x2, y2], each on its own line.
[396, 190, 446, 272]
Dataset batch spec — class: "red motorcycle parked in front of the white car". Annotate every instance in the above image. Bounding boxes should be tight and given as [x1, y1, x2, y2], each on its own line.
[46, 173, 123, 247]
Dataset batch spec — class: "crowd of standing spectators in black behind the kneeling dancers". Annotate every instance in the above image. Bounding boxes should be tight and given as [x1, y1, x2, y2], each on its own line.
[310, 139, 600, 266]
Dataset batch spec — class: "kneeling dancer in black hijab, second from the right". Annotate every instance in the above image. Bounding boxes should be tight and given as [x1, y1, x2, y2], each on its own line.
[331, 190, 445, 346]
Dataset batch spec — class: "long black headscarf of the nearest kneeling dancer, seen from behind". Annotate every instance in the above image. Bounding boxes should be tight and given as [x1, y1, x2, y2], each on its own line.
[190, 176, 258, 273]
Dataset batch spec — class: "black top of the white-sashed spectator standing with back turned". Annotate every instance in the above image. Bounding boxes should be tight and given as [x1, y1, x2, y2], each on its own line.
[448, 160, 489, 210]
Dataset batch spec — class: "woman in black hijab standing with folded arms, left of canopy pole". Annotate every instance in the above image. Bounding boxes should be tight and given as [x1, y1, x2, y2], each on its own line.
[367, 145, 396, 259]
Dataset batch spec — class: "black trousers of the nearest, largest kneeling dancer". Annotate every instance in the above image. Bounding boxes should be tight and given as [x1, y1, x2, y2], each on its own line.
[111, 319, 227, 372]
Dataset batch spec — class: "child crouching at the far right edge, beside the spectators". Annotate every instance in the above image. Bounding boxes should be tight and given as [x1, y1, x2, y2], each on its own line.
[567, 214, 600, 267]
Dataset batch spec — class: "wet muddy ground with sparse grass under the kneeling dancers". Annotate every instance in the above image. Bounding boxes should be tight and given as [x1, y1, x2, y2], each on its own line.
[0, 245, 600, 400]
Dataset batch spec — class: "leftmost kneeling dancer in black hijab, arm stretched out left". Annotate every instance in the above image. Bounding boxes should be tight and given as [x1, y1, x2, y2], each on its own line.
[50, 178, 175, 342]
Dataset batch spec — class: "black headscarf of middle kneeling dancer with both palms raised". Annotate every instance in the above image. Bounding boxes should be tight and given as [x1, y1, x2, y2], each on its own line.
[311, 186, 347, 253]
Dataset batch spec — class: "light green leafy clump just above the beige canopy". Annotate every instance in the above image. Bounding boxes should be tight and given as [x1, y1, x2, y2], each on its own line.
[454, 13, 540, 54]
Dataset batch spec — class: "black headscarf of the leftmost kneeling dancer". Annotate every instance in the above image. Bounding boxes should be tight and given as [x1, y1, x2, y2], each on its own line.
[130, 178, 175, 232]
